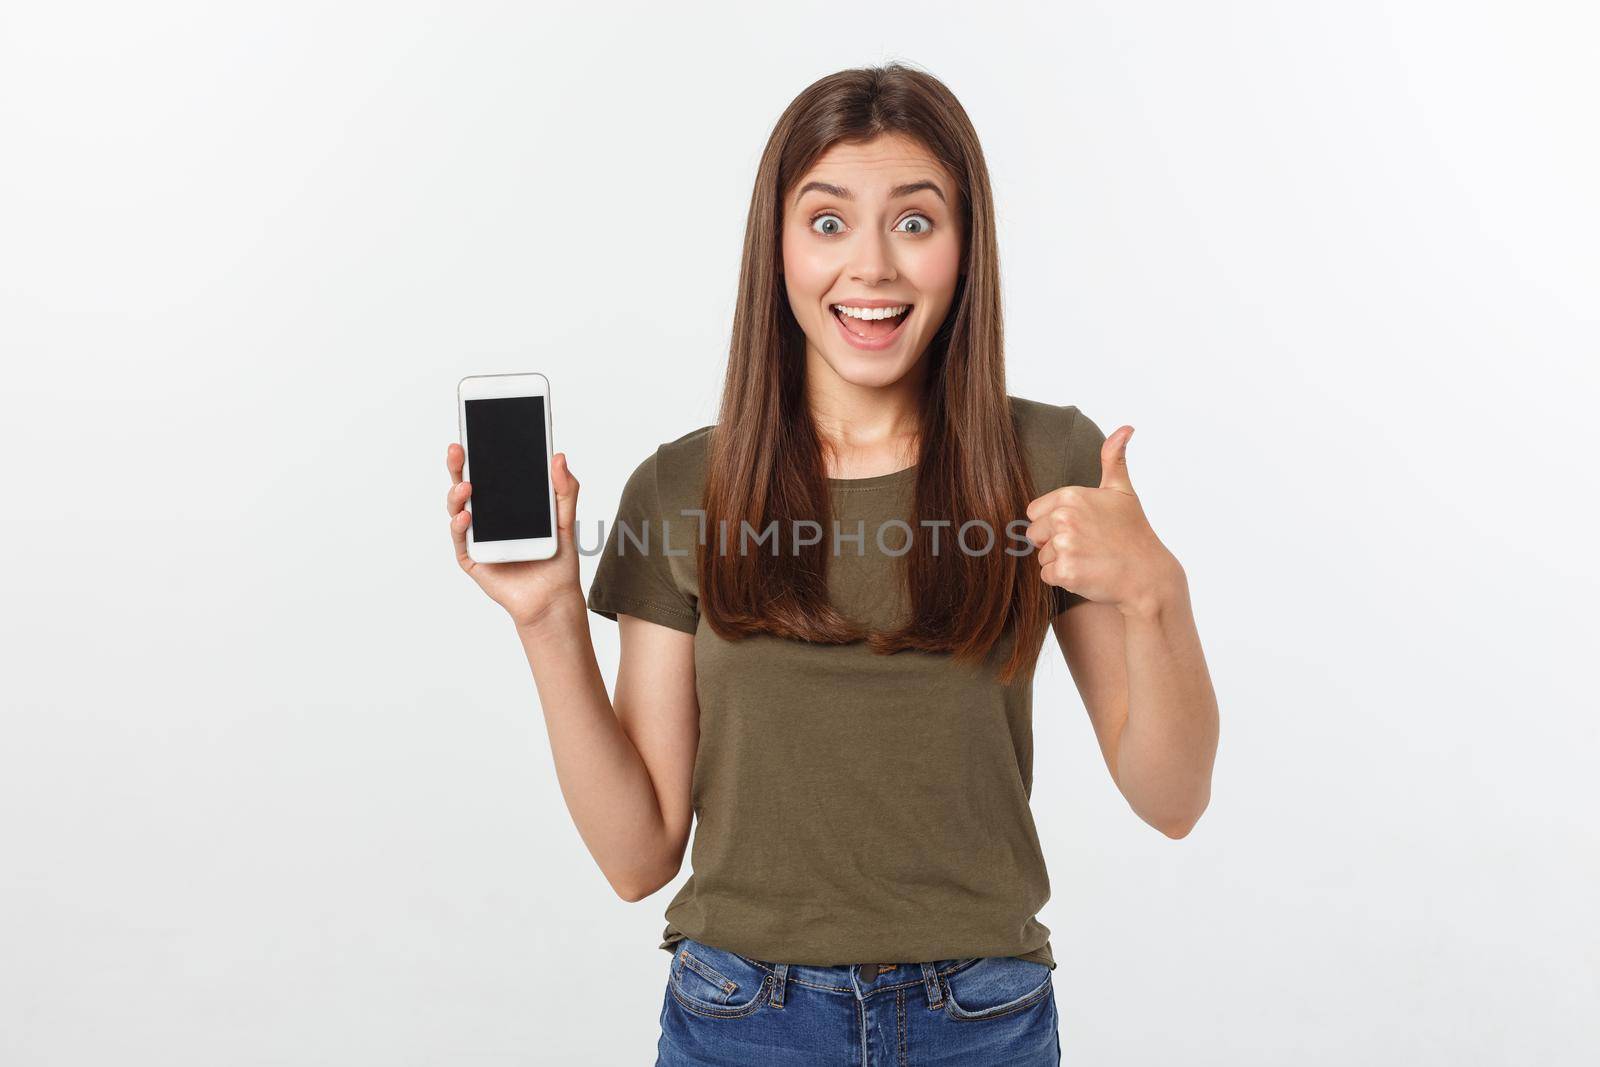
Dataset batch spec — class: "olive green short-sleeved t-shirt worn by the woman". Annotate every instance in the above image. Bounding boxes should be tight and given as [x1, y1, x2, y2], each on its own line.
[589, 397, 1106, 968]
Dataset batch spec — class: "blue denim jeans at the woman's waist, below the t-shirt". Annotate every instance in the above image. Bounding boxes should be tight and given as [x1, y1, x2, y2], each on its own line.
[656, 937, 1061, 1067]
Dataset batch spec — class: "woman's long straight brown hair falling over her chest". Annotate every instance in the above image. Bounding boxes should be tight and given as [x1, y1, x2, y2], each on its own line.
[698, 64, 1051, 681]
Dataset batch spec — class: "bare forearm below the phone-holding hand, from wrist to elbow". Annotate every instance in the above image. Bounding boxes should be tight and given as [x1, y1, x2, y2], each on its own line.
[517, 595, 675, 899]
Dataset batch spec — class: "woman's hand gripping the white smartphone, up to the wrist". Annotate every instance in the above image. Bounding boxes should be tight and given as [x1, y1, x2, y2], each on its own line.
[445, 442, 584, 629]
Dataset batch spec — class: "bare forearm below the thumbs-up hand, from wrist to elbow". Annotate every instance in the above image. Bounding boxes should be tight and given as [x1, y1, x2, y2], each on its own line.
[1117, 561, 1218, 837]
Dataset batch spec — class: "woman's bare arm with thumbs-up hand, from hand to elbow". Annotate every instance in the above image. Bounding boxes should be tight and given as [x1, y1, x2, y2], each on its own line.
[1027, 426, 1219, 838]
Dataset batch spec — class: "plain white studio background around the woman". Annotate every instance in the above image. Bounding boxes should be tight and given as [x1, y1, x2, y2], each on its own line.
[0, 0, 1600, 1067]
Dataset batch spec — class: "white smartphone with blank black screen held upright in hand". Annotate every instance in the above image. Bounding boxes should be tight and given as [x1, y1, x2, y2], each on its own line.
[456, 374, 557, 563]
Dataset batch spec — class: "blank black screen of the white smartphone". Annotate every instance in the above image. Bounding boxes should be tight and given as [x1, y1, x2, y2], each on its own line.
[467, 397, 555, 541]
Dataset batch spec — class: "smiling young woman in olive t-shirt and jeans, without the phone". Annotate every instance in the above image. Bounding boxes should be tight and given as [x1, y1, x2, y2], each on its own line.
[446, 64, 1218, 1067]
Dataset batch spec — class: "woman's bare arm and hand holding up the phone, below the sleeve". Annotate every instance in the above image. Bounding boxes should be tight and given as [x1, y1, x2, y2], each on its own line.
[446, 445, 699, 901]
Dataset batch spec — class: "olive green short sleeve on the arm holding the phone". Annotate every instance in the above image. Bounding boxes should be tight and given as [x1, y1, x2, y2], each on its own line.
[589, 453, 699, 633]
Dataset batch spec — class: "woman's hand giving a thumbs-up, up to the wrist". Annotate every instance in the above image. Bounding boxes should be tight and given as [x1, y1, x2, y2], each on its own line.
[1027, 426, 1184, 616]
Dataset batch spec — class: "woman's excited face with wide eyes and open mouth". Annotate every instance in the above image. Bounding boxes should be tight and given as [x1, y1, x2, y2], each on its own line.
[782, 134, 963, 386]
